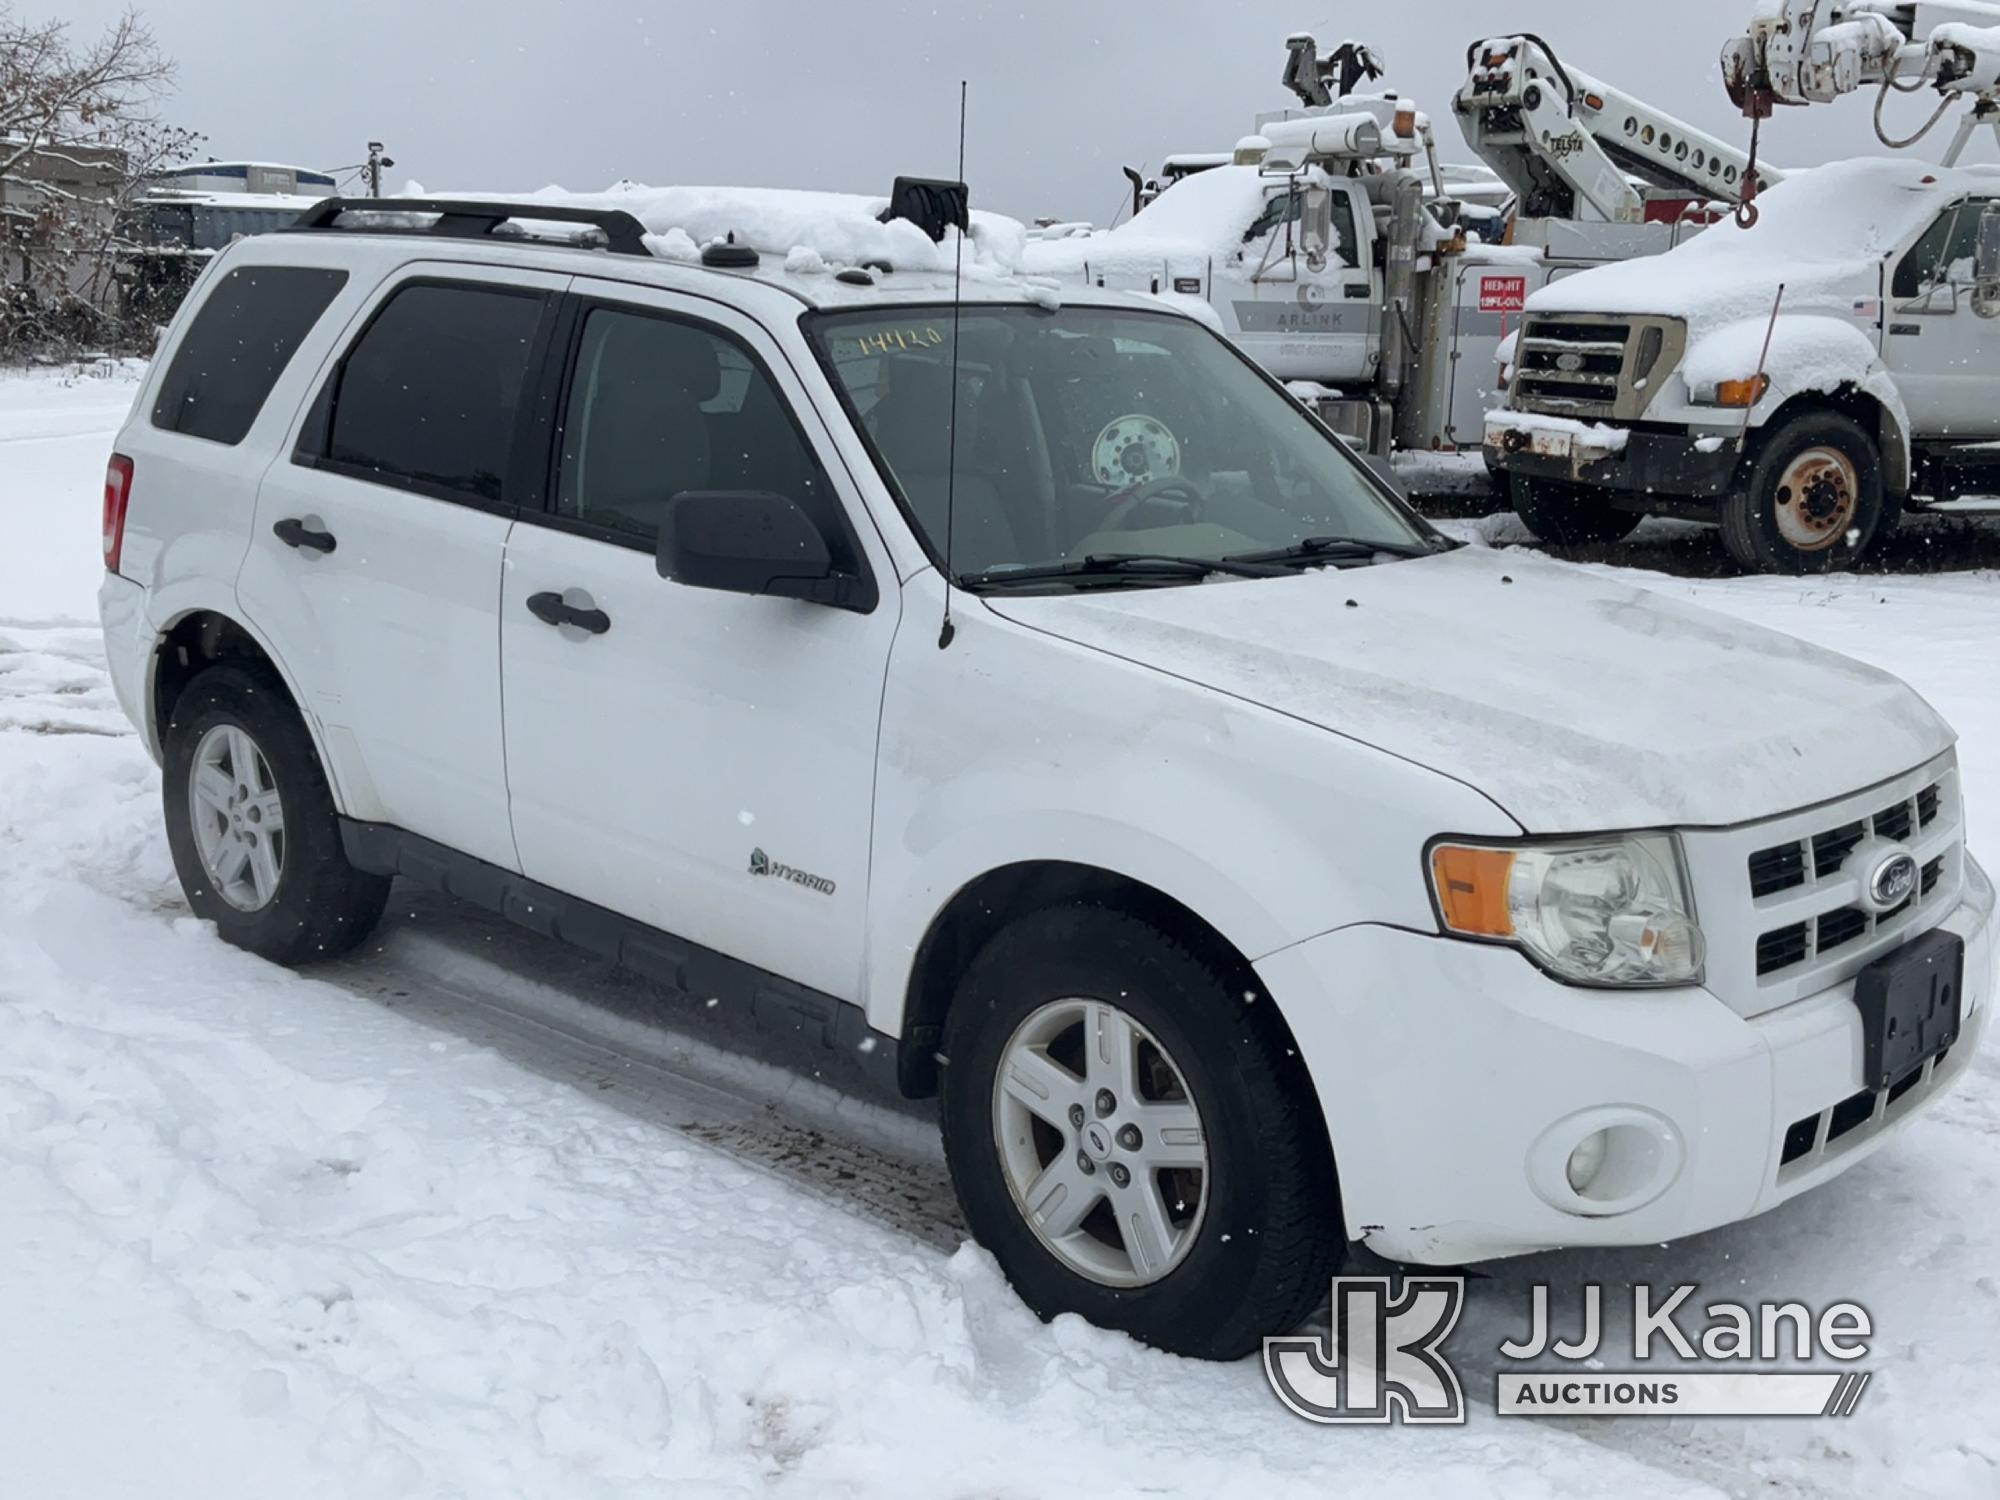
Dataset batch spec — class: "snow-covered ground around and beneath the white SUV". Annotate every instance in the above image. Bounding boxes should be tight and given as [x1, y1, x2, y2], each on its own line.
[0, 372, 2000, 1500]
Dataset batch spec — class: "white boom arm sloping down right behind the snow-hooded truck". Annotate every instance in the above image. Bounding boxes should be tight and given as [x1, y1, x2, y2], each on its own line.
[1452, 34, 1782, 224]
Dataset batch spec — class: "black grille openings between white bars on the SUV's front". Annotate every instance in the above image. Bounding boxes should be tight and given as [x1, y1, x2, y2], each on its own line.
[1746, 782, 1944, 980]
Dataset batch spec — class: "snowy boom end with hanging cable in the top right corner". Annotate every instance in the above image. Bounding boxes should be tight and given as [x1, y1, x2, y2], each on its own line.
[1722, 0, 2000, 166]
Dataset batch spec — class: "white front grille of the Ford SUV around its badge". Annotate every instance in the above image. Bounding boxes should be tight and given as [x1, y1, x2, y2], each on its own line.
[1682, 754, 1964, 1016]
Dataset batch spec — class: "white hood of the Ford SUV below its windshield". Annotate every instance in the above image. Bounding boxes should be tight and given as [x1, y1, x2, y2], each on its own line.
[986, 548, 1954, 834]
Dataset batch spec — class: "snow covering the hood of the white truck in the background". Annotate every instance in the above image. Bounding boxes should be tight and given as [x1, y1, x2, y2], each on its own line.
[1528, 158, 2000, 332]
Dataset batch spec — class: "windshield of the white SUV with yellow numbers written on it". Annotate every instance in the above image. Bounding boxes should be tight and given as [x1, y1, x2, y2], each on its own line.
[806, 306, 1442, 586]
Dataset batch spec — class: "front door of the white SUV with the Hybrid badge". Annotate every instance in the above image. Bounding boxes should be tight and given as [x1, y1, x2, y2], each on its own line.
[500, 282, 898, 1000]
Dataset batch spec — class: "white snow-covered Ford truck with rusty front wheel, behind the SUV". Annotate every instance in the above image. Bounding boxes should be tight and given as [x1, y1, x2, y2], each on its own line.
[1486, 160, 2000, 572]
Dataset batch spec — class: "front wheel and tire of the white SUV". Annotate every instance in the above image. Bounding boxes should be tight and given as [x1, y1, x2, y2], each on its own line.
[940, 904, 1346, 1360]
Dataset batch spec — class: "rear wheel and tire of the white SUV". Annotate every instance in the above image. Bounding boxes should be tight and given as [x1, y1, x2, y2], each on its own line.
[160, 664, 390, 966]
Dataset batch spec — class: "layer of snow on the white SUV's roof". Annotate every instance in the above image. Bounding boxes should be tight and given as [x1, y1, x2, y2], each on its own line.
[466, 182, 1028, 276]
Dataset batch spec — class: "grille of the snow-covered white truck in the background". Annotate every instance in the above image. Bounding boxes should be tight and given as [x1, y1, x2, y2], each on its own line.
[1510, 312, 1688, 422]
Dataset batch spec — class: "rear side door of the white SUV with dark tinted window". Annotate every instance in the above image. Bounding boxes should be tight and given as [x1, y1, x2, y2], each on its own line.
[238, 264, 568, 868]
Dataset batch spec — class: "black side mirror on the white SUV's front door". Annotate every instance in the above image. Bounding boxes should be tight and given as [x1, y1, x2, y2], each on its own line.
[654, 490, 874, 610]
